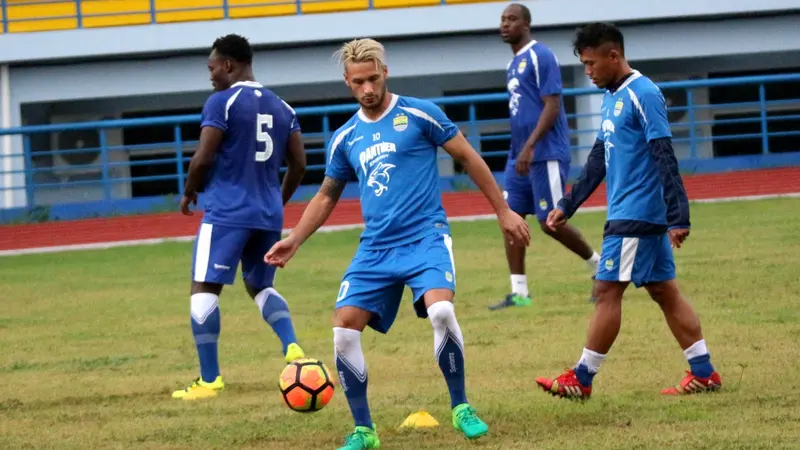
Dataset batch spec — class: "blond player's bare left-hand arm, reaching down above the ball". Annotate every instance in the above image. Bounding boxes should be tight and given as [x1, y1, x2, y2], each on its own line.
[264, 176, 347, 267]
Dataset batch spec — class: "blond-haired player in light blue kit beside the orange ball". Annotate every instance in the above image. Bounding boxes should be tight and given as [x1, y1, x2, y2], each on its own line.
[265, 39, 530, 450]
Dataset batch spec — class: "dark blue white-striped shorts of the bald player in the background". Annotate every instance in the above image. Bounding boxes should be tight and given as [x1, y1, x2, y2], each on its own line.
[503, 159, 569, 222]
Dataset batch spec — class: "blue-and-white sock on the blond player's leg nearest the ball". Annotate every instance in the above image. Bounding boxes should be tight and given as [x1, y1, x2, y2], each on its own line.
[333, 327, 372, 428]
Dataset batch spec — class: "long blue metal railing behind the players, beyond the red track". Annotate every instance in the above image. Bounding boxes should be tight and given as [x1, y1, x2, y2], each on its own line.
[0, 74, 800, 221]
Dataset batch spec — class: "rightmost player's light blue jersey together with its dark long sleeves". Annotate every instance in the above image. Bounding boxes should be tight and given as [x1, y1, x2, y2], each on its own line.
[559, 71, 690, 236]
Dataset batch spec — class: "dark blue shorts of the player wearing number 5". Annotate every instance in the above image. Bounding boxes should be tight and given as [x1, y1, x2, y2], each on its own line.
[192, 222, 281, 291]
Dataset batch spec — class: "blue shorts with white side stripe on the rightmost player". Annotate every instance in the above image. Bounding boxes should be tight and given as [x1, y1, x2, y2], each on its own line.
[595, 233, 675, 288]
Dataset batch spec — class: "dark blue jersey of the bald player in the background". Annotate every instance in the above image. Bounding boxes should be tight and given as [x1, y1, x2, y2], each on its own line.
[506, 41, 570, 162]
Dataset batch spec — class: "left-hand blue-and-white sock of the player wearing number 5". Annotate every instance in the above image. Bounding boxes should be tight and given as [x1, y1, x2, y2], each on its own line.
[190, 294, 221, 383]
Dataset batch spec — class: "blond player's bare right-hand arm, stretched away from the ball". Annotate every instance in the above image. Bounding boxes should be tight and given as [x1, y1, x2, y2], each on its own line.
[442, 132, 531, 246]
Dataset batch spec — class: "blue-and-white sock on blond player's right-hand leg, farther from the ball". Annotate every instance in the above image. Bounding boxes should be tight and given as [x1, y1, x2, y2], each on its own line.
[428, 301, 467, 408]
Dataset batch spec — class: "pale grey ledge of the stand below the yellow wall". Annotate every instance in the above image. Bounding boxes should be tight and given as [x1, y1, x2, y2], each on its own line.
[0, 0, 800, 64]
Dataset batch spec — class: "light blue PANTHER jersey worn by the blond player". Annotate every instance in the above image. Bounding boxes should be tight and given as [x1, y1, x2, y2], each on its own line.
[325, 94, 458, 249]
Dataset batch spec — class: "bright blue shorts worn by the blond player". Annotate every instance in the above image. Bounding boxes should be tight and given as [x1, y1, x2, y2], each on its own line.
[336, 233, 456, 333]
